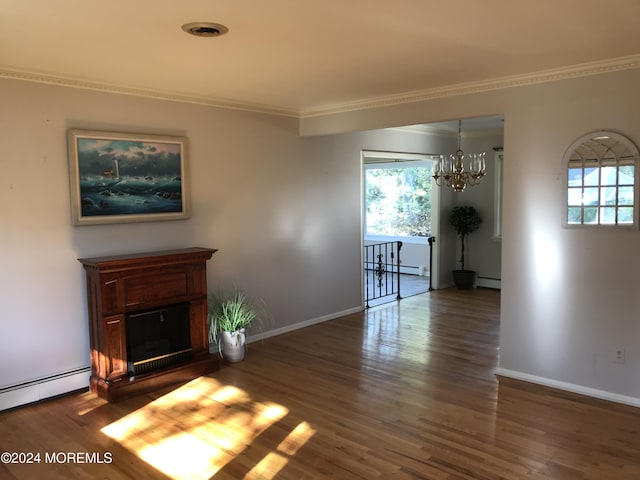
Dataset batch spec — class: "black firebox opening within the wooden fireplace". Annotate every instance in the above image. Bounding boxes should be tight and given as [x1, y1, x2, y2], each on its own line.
[126, 303, 193, 376]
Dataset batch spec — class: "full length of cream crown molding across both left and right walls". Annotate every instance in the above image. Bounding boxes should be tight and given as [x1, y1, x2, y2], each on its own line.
[0, 54, 640, 119]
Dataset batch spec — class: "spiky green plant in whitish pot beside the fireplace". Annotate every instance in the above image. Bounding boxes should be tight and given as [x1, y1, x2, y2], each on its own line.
[208, 289, 260, 363]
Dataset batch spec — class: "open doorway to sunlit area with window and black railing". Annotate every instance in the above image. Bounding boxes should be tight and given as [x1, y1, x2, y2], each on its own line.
[362, 150, 439, 305]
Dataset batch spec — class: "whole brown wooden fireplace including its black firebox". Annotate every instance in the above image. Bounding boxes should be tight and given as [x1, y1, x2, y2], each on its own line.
[78, 248, 219, 401]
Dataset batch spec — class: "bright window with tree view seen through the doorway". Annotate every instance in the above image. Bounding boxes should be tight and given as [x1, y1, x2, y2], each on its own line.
[364, 157, 433, 237]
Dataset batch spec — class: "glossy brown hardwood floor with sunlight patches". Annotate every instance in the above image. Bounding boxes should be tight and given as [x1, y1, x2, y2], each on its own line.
[0, 289, 640, 480]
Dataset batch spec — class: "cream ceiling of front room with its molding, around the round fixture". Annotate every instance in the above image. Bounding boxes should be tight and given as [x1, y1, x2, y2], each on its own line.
[0, 0, 640, 117]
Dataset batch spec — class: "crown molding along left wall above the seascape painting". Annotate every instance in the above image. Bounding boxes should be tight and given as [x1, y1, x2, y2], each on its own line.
[0, 66, 299, 118]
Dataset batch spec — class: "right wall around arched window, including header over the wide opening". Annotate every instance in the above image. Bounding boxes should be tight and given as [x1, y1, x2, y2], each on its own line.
[301, 69, 640, 405]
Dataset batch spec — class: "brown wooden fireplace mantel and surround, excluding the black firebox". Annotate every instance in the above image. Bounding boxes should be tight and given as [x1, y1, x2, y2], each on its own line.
[78, 247, 218, 401]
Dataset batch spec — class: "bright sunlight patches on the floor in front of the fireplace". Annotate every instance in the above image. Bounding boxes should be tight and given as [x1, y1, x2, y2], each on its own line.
[102, 377, 315, 480]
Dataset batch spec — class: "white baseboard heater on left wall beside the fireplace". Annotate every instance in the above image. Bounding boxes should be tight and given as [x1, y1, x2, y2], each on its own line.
[0, 367, 91, 411]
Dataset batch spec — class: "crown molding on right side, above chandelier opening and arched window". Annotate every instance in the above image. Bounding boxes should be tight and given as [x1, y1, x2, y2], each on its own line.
[300, 54, 640, 118]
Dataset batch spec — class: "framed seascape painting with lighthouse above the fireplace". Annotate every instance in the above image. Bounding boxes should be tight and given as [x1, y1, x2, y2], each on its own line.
[67, 129, 189, 225]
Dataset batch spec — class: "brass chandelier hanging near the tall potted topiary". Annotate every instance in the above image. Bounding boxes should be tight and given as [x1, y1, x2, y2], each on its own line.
[433, 120, 487, 192]
